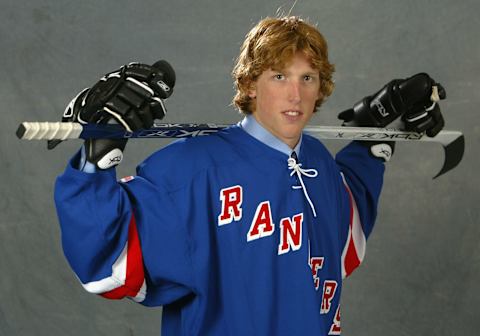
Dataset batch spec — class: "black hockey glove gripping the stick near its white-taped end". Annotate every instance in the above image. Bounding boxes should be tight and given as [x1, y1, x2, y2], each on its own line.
[48, 61, 175, 169]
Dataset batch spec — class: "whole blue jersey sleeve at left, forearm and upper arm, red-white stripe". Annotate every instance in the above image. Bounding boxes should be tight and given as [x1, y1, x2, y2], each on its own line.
[55, 151, 192, 306]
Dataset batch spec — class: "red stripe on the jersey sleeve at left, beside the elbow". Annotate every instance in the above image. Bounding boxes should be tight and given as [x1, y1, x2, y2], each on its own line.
[101, 215, 145, 299]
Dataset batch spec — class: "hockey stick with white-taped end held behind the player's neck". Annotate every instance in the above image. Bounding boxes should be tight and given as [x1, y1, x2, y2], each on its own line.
[17, 122, 465, 178]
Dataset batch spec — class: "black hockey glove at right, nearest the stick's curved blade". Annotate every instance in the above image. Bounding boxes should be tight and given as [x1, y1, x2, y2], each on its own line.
[338, 73, 446, 161]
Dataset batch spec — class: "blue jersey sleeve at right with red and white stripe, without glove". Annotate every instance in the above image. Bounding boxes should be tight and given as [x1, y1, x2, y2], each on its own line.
[336, 142, 385, 278]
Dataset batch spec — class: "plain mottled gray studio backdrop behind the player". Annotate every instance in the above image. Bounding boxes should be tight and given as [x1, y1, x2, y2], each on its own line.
[0, 0, 480, 335]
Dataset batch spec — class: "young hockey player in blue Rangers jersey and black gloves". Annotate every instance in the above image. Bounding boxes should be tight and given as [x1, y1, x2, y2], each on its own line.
[55, 17, 443, 336]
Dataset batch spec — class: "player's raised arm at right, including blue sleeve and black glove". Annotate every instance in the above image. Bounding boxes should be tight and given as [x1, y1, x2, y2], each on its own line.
[336, 73, 445, 277]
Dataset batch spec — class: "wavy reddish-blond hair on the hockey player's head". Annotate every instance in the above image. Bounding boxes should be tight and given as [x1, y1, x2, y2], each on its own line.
[232, 16, 335, 114]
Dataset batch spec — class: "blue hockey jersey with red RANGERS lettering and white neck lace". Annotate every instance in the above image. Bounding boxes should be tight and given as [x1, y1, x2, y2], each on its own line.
[55, 122, 384, 336]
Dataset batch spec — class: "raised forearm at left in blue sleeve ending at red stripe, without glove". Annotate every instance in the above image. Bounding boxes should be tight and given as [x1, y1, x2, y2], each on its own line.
[55, 155, 145, 301]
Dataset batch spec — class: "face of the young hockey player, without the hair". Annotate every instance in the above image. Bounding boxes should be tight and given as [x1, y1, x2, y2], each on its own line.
[249, 54, 320, 148]
